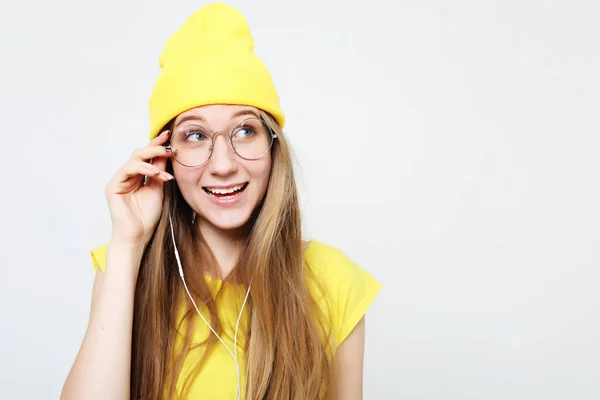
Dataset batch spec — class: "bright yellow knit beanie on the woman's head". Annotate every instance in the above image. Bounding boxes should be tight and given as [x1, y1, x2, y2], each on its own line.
[149, 3, 285, 140]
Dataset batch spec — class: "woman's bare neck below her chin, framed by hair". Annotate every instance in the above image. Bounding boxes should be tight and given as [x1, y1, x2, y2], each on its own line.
[199, 220, 249, 278]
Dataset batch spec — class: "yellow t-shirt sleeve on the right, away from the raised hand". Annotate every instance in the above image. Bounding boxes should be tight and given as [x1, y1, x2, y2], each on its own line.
[305, 241, 381, 347]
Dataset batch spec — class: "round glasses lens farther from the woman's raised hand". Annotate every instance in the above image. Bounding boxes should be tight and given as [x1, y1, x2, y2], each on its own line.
[231, 118, 273, 160]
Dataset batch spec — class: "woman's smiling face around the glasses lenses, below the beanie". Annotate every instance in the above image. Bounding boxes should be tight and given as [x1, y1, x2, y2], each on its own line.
[172, 105, 271, 230]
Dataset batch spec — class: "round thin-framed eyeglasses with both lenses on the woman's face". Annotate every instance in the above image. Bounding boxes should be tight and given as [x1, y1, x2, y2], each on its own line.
[166, 118, 277, 167]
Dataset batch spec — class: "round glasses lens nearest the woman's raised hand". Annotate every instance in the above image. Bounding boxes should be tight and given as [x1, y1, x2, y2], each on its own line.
[171, 125, 212, 167]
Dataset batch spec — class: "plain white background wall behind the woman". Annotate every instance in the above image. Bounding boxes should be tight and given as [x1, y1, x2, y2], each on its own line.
[0, 0, 600, 400]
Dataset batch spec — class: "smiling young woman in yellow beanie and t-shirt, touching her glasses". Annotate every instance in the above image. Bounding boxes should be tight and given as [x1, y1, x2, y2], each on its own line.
[61, 3, 380, 400]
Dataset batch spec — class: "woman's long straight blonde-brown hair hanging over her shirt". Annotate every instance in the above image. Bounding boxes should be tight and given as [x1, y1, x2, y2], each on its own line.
[131, 111, 333, 400]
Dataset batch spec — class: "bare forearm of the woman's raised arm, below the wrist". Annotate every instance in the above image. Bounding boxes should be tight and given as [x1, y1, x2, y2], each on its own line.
[61, 244, 143, 400]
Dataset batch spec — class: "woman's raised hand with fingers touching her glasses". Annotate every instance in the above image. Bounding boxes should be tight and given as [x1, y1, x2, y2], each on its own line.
[105, 131, 173, 246]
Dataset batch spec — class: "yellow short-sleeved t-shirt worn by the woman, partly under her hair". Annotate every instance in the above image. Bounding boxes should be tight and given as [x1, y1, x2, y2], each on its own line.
[92, 240, 381, 399]
